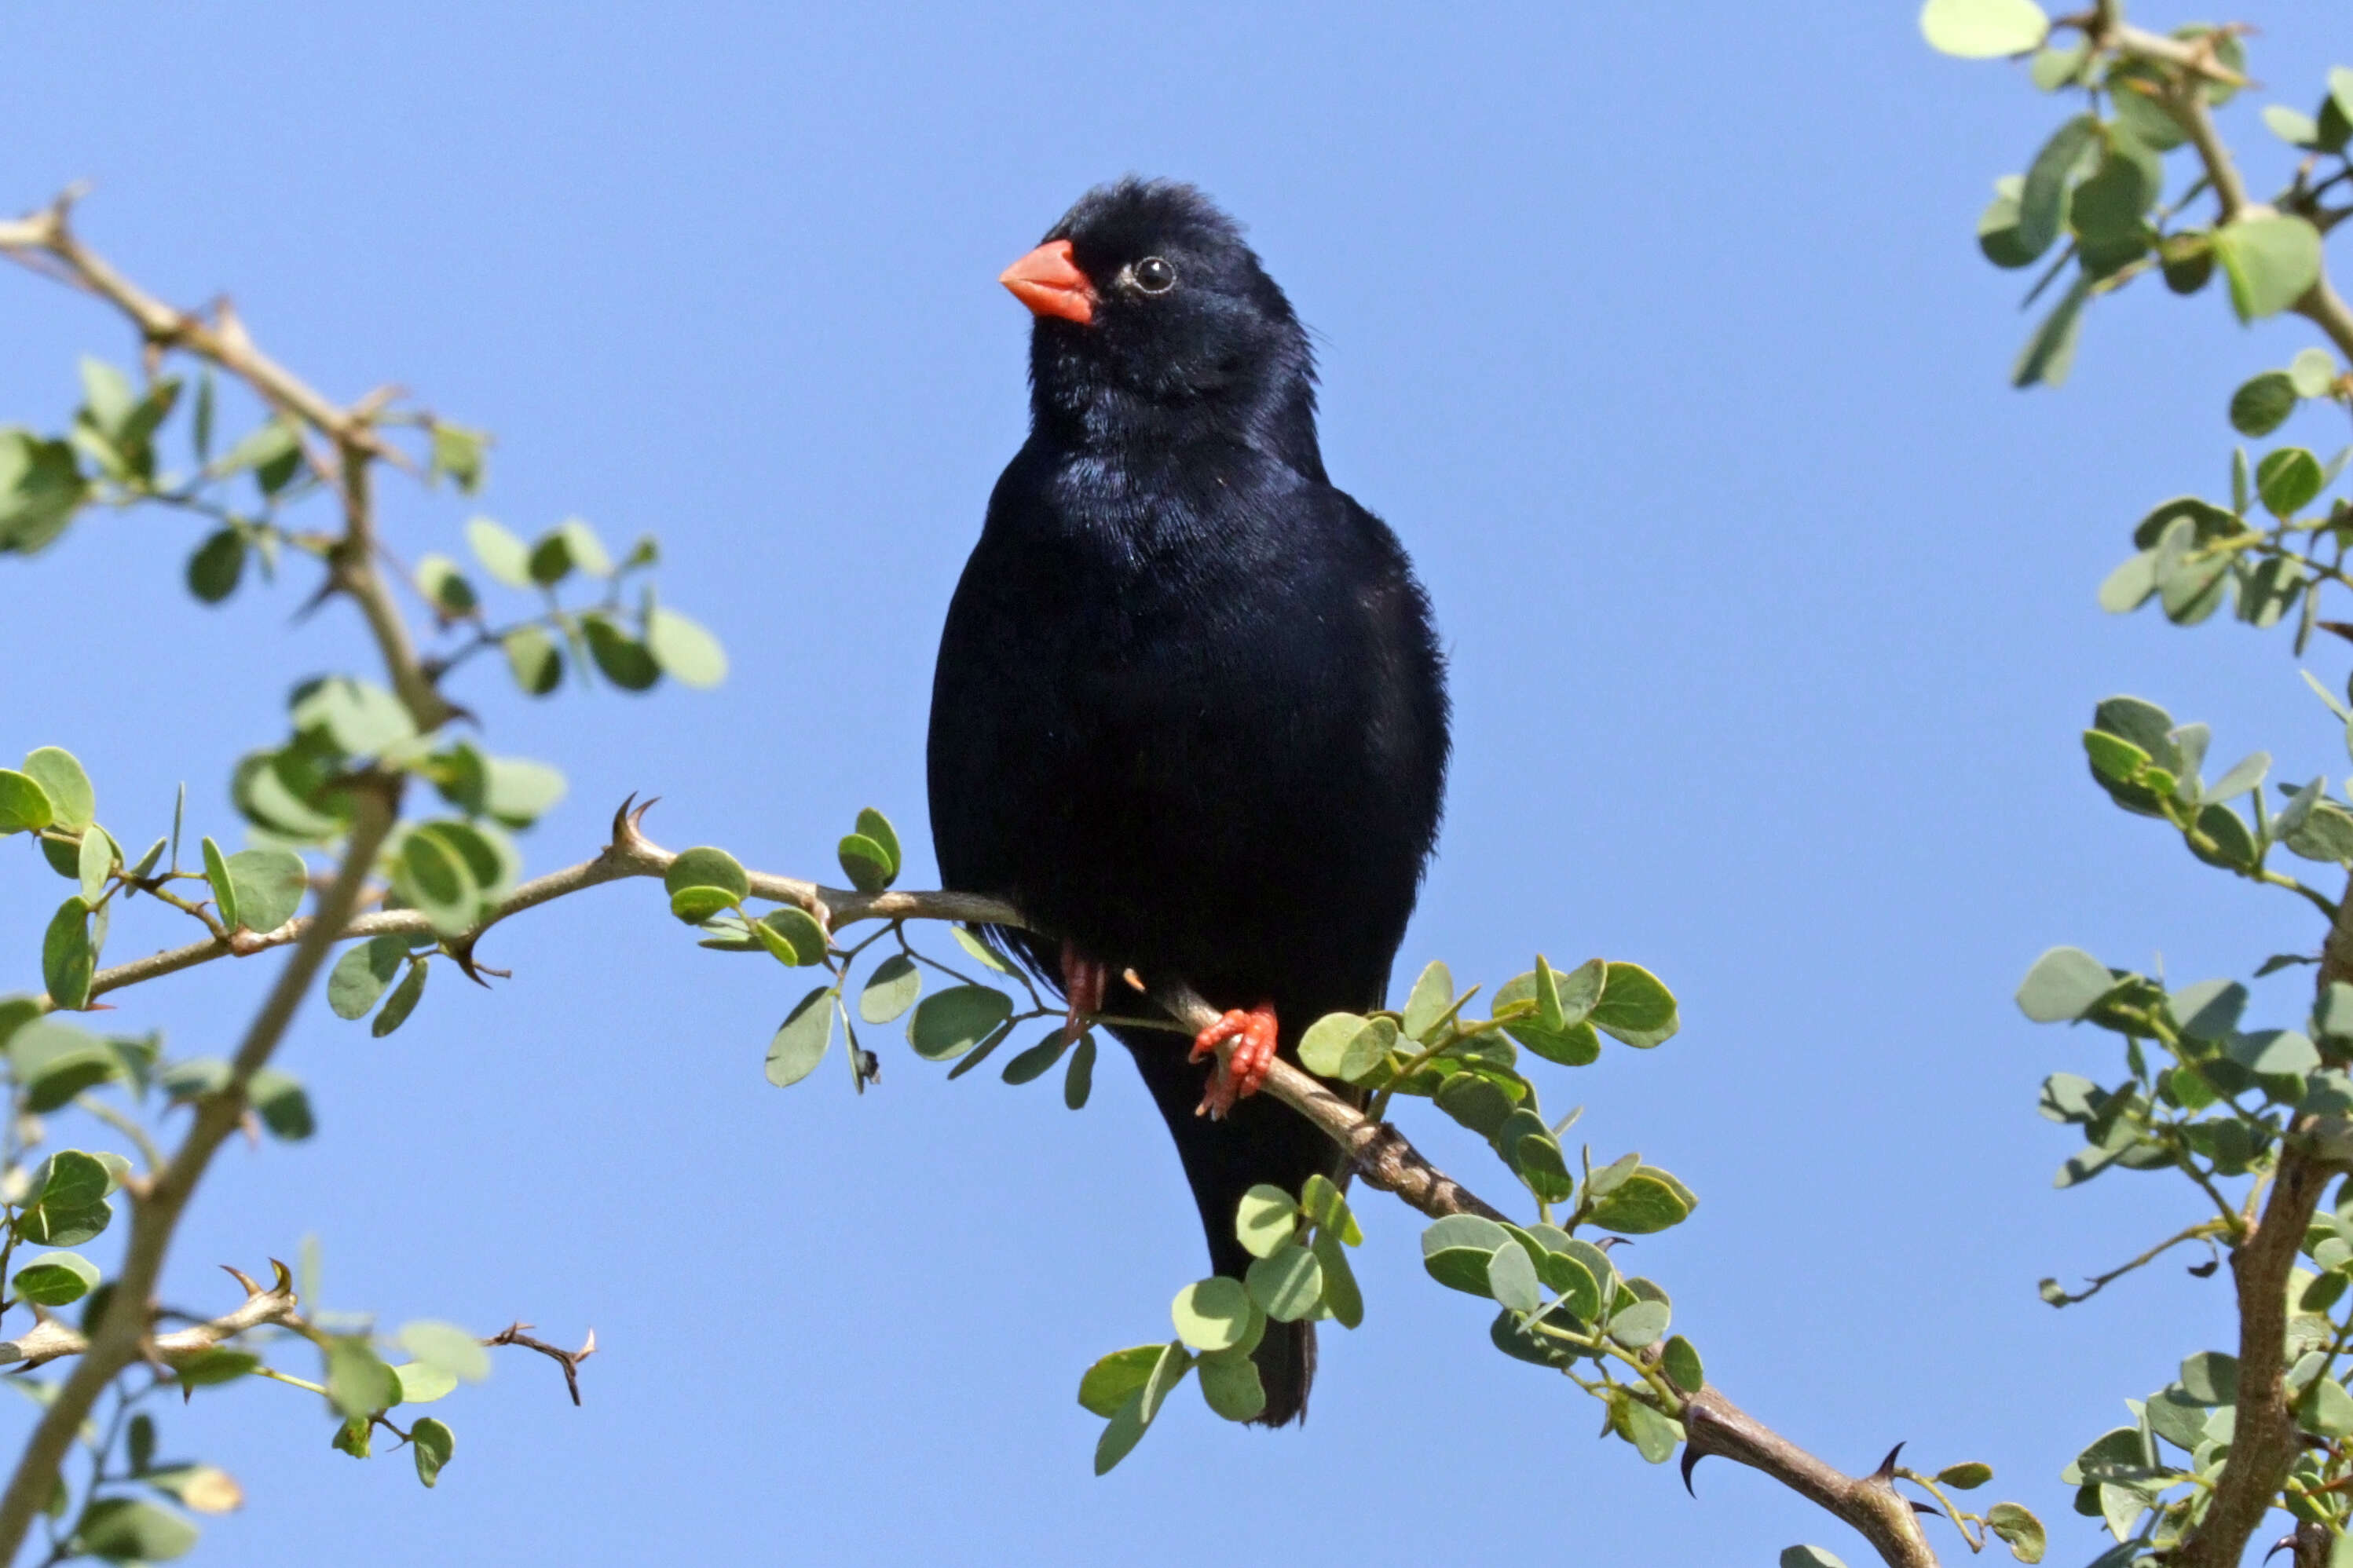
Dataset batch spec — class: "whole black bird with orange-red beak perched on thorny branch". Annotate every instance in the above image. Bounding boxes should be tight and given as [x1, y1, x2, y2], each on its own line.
[929, 179, 1447, 1427]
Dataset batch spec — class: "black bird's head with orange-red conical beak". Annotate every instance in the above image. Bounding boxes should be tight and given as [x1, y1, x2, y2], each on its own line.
[1000, 177, 1320, 473]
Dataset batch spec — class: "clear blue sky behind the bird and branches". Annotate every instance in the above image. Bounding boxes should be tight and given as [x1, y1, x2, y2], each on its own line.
[0, 0, 2344, 1566]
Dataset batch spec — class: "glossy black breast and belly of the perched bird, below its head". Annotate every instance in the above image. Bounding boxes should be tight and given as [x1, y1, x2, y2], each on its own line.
[929, 440, 1447, 1034]
